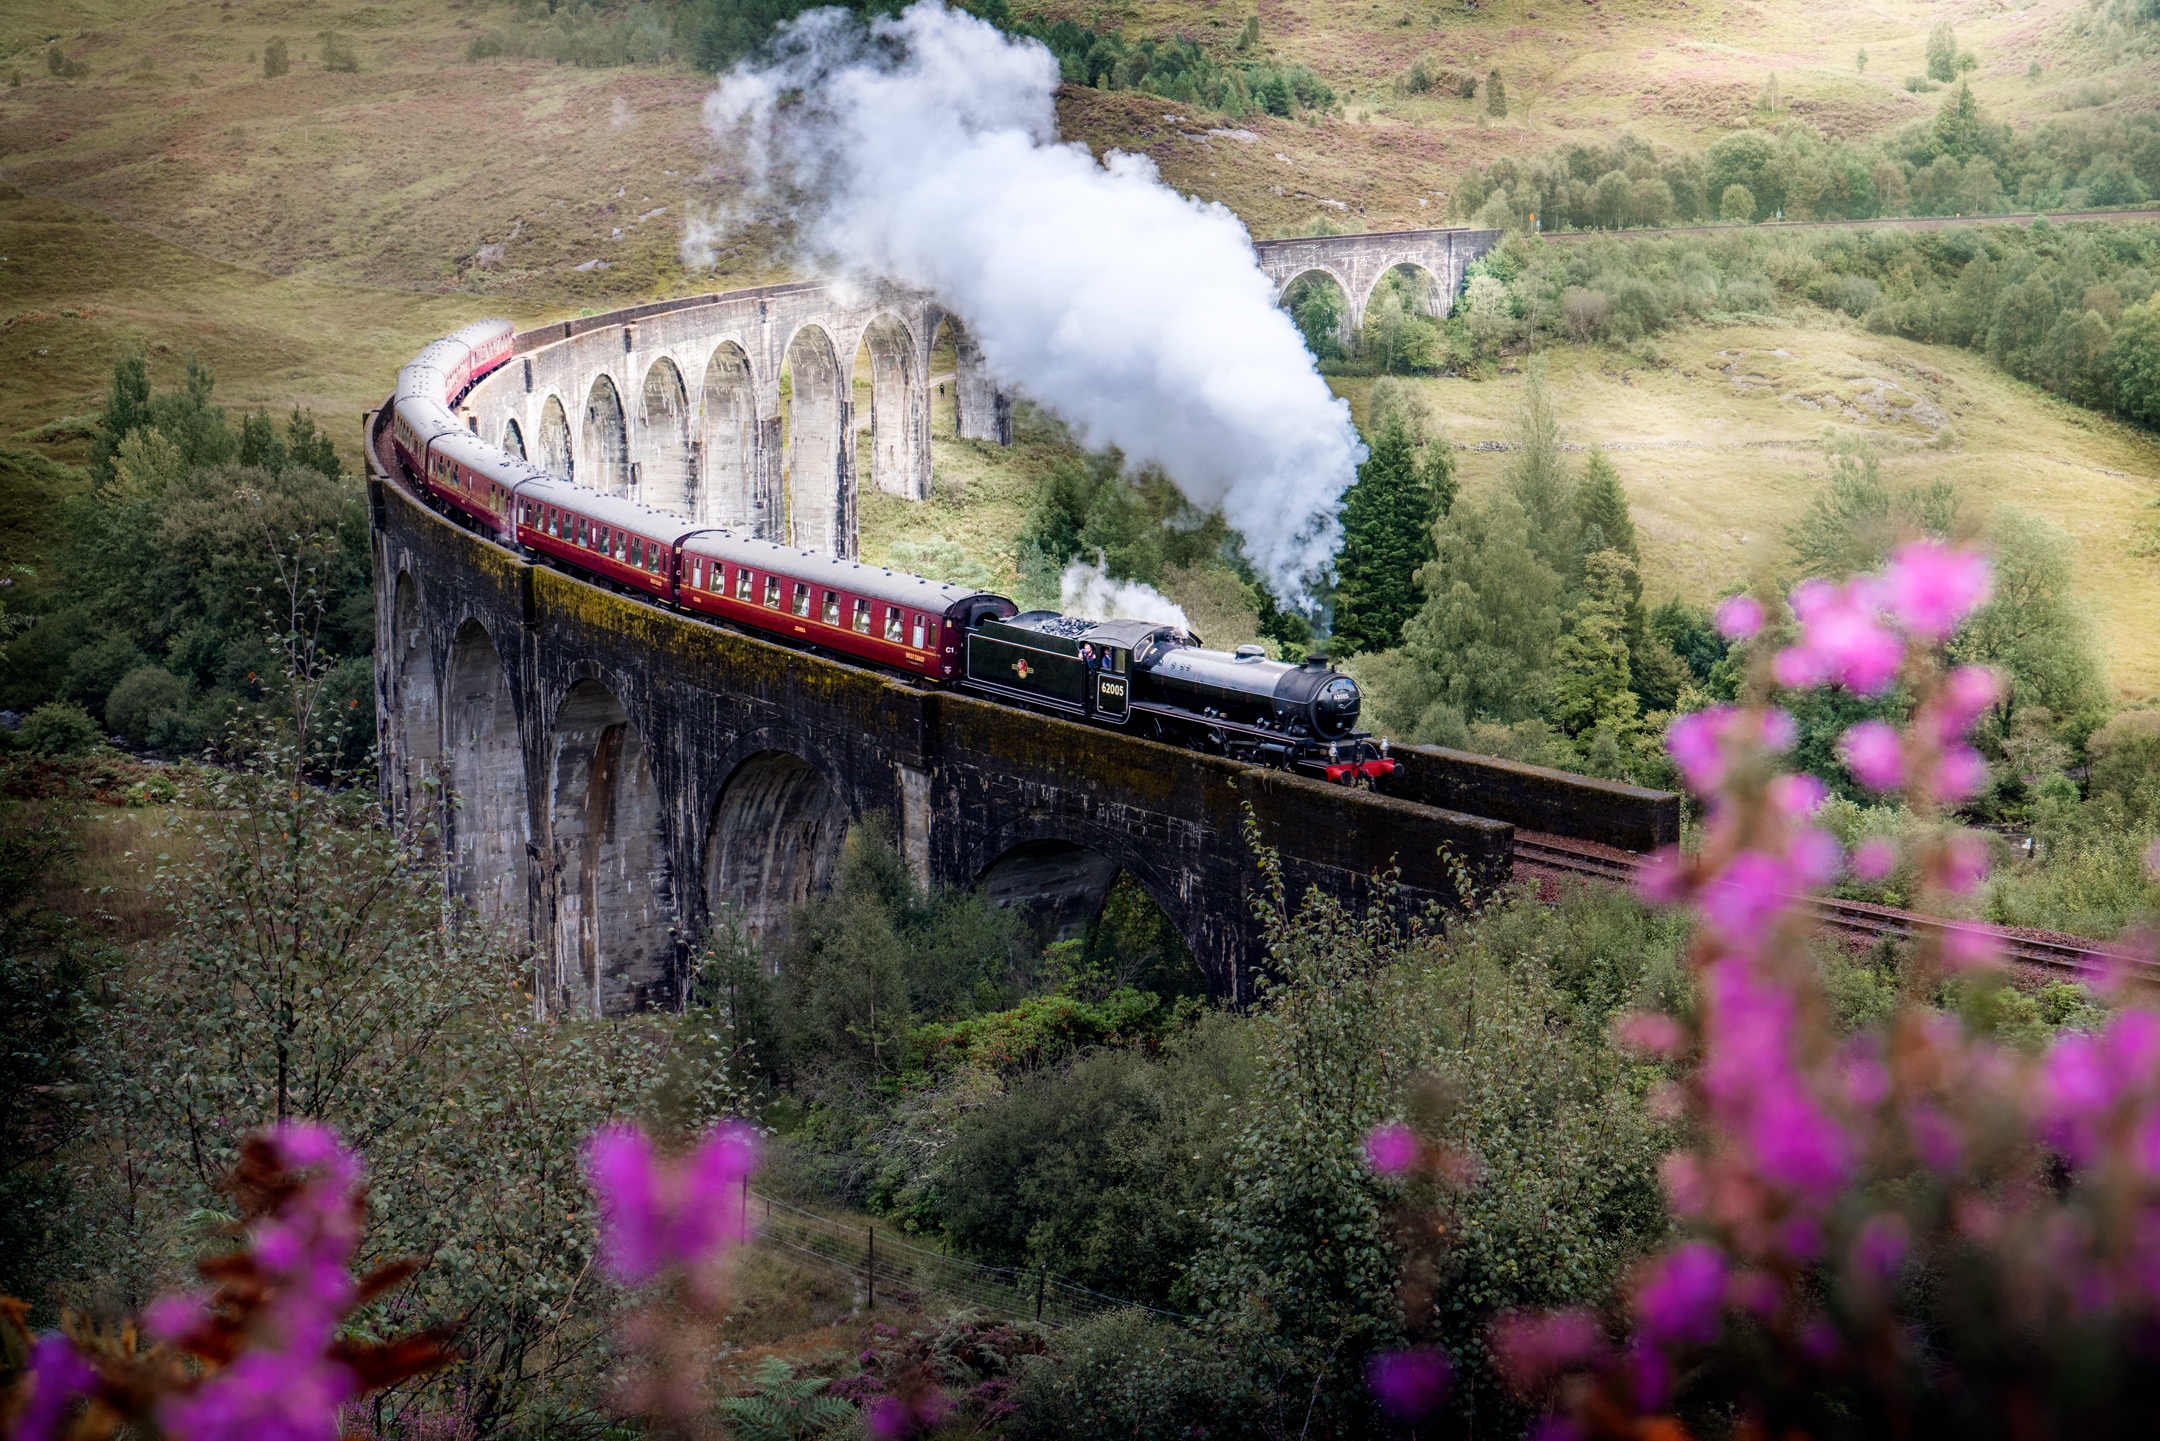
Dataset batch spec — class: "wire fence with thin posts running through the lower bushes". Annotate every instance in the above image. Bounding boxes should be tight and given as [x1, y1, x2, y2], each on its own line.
[747, 1190, 1194, 1326]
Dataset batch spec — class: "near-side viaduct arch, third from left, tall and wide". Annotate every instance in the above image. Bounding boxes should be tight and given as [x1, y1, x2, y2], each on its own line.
[546, 681, 676, 1015]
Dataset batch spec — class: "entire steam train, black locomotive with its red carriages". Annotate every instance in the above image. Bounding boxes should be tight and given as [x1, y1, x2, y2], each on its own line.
[389, 320, 1395, 786]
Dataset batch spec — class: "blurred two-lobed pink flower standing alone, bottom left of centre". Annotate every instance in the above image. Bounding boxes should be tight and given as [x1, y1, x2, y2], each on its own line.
[585, 1126, 756, 1285]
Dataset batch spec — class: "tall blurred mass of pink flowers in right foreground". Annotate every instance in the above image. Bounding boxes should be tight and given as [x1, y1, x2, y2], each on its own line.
[1490, 542, 2160, 1439]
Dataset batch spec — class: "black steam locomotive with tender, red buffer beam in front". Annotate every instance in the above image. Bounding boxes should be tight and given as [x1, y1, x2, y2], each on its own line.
[966, 611, 1395, 786]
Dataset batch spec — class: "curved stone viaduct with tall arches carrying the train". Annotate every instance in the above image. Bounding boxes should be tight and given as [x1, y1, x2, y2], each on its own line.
[367, 238, 1678, 1015]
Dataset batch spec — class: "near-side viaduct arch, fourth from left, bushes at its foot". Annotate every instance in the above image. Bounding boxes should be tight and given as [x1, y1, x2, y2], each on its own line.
[704, 750, 849, 944]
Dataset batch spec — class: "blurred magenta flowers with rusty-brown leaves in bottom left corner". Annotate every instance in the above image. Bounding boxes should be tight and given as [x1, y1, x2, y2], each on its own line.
[6, 1126, 454, 1441]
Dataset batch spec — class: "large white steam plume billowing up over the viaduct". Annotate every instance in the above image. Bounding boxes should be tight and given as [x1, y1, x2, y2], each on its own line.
[685, 0, 1363, 603]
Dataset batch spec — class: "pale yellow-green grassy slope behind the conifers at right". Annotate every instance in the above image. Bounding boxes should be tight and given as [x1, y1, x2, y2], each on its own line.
[1335, 324, 2160, 696]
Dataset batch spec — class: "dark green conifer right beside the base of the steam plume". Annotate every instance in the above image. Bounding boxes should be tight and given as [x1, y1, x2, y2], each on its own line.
[1333, 413, 1454, 655]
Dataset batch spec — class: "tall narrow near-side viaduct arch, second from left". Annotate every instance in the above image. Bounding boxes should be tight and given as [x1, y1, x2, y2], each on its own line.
[445, 620, 531, 922]
